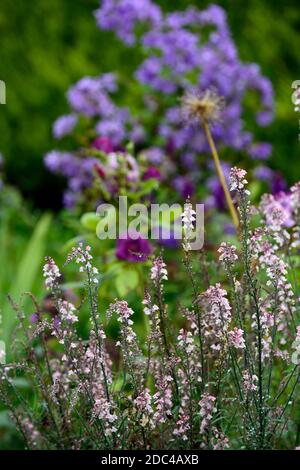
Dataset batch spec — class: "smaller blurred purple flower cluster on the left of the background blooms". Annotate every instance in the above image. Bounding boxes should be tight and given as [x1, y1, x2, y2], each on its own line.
[45, 73, 150, 209]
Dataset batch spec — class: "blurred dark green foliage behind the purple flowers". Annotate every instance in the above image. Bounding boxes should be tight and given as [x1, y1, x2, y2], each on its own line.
[0, 0, 300, 209]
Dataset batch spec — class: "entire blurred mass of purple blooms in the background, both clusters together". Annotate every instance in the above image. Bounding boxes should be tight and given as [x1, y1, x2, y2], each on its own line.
[45, 0, 274, 208]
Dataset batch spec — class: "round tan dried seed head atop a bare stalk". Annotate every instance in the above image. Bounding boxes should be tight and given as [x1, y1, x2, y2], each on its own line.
[181, 90, 225, 124]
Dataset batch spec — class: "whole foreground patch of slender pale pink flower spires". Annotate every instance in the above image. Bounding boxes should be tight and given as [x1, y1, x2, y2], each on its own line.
[0, 168, 300, 450]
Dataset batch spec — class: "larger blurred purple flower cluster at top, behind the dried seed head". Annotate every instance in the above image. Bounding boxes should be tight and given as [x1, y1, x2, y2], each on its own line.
[96, 0, 273, 165]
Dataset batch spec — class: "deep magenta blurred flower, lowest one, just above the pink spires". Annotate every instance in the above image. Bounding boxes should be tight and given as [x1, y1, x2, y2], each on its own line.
[116, 235, 152, 263]
